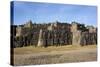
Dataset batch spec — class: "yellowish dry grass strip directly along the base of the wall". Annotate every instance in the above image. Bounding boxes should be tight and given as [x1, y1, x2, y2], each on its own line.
[14, 45, 96, 54]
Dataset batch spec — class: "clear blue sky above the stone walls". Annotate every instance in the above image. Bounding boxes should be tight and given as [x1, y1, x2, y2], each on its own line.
[13, 1, 97, 26]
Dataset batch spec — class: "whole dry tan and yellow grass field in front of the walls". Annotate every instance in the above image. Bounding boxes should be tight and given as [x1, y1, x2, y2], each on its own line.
[14, 45, 97, 65]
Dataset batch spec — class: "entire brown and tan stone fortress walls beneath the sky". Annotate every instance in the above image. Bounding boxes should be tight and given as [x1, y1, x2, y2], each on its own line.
[11, 21, 97, 47]
